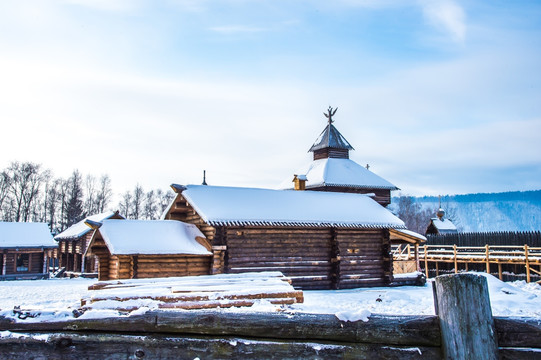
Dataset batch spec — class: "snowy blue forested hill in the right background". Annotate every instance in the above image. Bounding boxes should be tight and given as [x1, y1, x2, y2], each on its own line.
[393, 190, 541, 232]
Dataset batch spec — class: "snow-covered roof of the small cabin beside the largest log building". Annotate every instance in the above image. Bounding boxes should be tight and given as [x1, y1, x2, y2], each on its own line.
[94, 220, 212, 255]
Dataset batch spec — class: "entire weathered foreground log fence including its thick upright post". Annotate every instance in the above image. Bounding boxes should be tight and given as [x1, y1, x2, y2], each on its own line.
[0, 274, 541, 360]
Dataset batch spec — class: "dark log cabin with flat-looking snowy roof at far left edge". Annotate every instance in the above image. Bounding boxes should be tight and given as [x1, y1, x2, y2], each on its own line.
[0, 222, 58, 280]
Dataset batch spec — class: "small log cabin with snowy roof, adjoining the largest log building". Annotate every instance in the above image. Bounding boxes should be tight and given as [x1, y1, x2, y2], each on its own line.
[86, 220, 212, 281]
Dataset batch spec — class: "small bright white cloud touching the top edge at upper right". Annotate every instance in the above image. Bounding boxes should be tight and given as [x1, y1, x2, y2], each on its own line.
[420, 0, 466, 43]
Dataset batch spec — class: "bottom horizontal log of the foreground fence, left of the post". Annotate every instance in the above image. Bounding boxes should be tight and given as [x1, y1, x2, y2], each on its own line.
[0, 333, 439, 360]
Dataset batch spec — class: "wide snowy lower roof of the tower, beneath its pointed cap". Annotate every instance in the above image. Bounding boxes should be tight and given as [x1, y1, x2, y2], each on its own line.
[280, 158, 398, 190]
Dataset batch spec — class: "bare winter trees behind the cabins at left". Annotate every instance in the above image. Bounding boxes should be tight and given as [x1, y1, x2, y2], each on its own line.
[0, 161, 174, 233]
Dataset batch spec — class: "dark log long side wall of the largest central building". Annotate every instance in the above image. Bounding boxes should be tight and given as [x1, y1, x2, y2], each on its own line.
[216, 227, 391, 289]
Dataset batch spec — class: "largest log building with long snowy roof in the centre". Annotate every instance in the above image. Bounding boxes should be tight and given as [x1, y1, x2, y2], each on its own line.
[164, 185, 405, 289]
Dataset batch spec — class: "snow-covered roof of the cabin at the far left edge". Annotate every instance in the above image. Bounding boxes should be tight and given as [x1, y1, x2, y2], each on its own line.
[0, 222, 58, 248]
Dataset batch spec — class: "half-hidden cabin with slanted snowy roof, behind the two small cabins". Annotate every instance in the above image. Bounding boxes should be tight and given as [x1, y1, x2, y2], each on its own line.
[54, 211, 124, 276]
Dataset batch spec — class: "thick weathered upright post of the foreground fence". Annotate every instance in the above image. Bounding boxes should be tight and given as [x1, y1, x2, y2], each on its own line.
[433, 273, 498, 359]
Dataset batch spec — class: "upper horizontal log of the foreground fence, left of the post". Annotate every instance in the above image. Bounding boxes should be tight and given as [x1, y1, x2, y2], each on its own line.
[0, 310, 440, 346]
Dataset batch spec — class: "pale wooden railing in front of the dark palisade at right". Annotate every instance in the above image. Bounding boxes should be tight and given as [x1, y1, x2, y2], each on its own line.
[392, 244, 541, 282]
